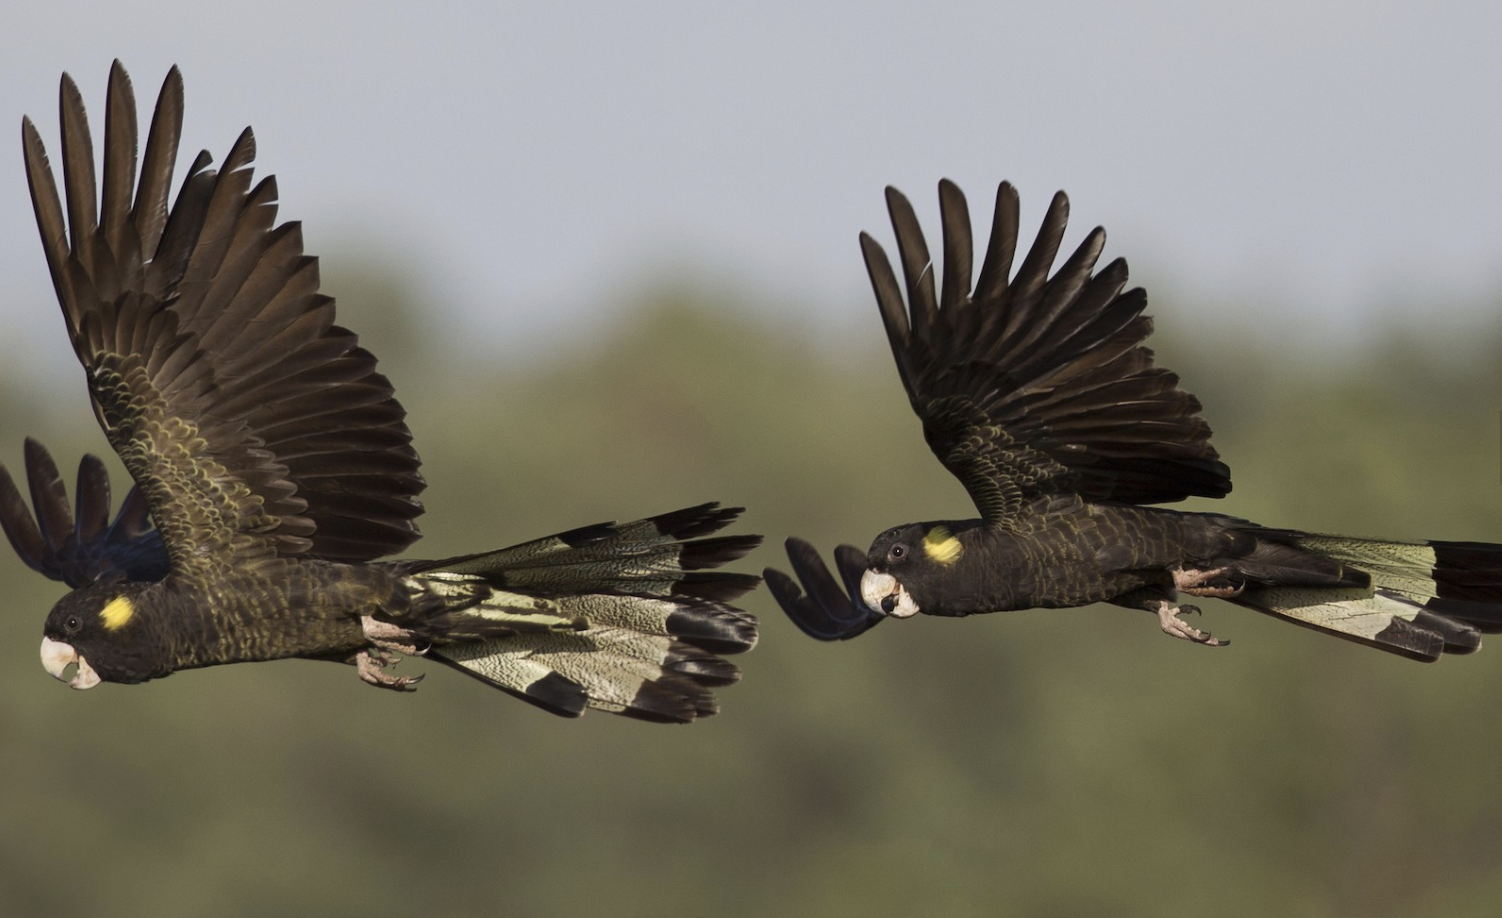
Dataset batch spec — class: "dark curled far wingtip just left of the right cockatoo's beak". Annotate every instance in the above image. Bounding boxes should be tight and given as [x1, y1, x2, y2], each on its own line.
[763, 538, 885, 640]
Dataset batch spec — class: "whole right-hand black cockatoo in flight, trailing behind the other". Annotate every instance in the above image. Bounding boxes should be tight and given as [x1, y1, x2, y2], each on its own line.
[765, 180, 1502, 660]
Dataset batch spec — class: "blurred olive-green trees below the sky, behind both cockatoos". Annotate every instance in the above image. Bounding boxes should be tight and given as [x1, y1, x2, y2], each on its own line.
[0, 250, 1502, 918]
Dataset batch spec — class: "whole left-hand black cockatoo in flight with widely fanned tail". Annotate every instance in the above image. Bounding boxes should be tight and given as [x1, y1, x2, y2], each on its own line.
[0, 62, 760, 721]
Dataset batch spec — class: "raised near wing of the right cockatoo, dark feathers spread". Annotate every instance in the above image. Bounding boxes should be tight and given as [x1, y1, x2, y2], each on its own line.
[861, 180, 1230, 527]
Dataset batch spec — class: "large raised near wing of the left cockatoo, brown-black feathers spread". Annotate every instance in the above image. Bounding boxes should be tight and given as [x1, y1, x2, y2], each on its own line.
[23, 62, 424, 569]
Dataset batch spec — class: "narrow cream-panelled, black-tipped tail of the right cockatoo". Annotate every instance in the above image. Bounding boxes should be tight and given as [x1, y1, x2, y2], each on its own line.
[1232, 533, 1502, 661]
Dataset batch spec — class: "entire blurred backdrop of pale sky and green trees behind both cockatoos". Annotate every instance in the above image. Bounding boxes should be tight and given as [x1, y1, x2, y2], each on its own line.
[0, 2, 1502, 918]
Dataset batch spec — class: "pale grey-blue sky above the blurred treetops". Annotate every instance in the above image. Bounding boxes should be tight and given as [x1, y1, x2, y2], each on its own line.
[0, 0, 1502, 384]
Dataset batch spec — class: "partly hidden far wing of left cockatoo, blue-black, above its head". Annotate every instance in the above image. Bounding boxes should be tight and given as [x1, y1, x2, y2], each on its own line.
[0, 437, 167, 589]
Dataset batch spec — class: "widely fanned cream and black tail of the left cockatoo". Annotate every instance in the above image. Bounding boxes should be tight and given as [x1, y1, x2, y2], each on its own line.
[395, 503, 762, 723]
